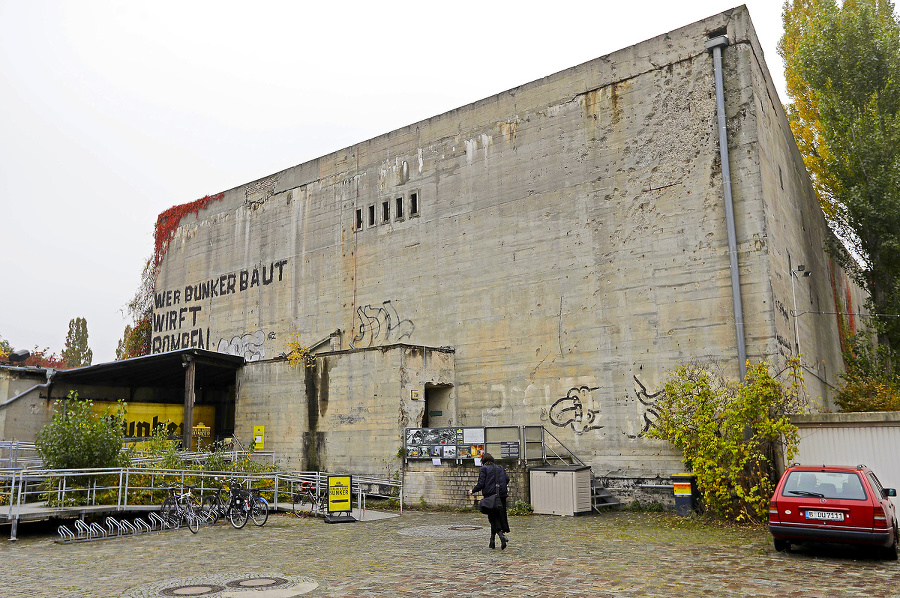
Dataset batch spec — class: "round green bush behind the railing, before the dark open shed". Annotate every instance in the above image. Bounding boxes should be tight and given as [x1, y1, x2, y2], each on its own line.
[34, 390, 125, 469]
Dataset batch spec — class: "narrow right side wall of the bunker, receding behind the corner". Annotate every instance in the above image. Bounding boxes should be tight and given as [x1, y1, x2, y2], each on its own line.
[740, 16, 866, 410]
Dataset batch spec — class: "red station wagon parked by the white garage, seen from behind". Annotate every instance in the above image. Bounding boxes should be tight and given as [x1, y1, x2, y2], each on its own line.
[769, 465, 898, 560]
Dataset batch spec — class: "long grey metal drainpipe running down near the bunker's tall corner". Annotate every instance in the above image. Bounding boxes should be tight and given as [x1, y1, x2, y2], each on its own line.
[706, 35, 747, 380]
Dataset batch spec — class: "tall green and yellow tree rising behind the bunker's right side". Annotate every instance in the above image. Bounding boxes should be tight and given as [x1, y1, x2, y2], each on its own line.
[779, 0, 900, 351]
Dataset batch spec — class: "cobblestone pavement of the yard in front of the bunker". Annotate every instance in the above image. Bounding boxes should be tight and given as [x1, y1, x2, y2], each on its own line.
[0, 511, 900, 598]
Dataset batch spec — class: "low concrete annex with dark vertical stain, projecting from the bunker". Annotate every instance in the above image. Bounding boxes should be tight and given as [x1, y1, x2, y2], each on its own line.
[235, 345, 454, 477]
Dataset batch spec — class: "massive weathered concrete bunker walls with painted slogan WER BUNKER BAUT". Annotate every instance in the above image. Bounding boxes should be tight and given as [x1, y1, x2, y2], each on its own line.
[152, 7, 861, 476]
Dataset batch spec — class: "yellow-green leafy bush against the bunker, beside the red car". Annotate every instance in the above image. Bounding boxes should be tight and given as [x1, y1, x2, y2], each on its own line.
[647, 360, 805, 521]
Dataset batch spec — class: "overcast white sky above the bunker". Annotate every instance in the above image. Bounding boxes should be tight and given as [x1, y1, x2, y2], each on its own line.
[0, 0, 786, 364]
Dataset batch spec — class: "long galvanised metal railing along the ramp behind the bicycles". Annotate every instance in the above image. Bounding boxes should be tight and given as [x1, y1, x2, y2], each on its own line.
[0, 467, 403, 539]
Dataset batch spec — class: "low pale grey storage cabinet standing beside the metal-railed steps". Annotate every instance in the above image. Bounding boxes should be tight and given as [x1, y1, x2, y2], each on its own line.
[529, 465, 591, 515]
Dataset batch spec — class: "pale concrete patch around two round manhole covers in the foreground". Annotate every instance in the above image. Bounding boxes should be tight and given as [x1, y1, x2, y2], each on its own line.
[122, 573, 319, 598]
